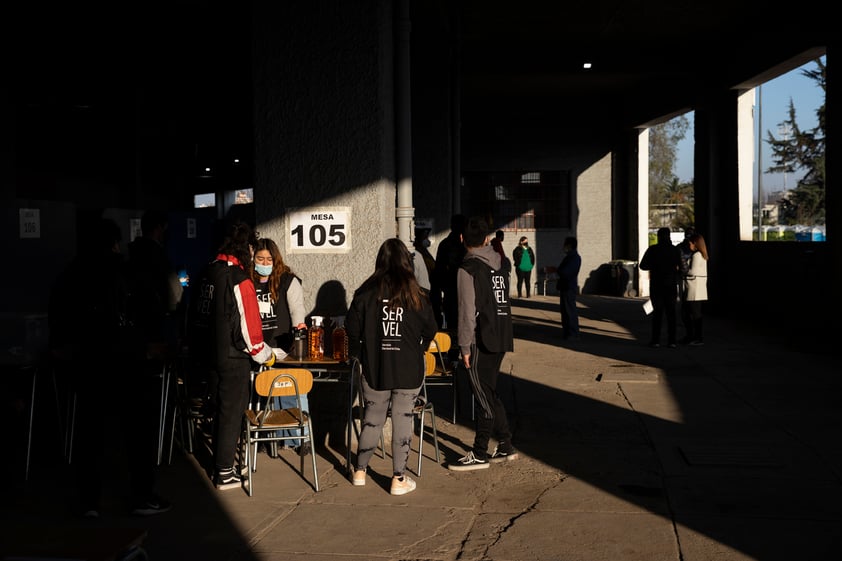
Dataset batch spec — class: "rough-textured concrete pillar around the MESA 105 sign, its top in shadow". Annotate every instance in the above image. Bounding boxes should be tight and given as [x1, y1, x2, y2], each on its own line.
[249, 1, 396, 315]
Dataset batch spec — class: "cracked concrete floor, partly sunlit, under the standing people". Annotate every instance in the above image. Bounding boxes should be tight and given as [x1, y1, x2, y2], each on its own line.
[0, 296, 842, 561]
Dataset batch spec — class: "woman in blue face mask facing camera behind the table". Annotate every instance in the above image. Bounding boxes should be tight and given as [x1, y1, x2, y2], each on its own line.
[251, 238, 311, 455]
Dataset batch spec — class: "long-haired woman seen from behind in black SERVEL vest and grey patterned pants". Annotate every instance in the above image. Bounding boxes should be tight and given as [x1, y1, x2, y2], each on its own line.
[345, 238, 438, 495]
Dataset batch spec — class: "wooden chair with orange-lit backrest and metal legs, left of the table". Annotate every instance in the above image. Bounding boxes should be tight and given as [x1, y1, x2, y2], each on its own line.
[242, 368, 319, 496]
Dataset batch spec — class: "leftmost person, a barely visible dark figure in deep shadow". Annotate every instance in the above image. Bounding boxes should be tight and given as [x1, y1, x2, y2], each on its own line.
[49, 218, 171, 518]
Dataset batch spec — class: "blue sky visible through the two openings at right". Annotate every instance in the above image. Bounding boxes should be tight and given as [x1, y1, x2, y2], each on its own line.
[675, 58, 827, 193]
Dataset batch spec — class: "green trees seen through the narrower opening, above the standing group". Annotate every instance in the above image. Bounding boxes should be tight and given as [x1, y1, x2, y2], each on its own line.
[649, 115, 695, 230]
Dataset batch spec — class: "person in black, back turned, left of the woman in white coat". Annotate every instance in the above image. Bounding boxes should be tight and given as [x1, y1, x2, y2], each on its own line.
[640, 227, 681, 349]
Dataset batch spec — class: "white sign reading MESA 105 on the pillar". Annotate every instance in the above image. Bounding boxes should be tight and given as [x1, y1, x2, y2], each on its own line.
[287, 207, 351, 253]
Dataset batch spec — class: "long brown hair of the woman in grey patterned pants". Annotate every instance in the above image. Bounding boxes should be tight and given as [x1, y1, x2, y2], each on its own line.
[357, 238, 427, 310]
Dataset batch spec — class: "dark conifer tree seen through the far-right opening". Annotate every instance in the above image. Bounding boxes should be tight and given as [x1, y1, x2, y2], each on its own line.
[766, 59, 827, 225]
